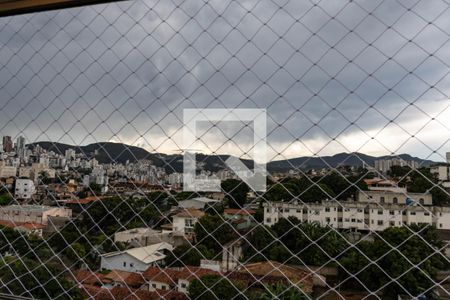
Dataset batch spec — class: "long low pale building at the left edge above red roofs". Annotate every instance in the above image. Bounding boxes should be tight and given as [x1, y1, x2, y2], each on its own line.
[0, 205, 72, 225]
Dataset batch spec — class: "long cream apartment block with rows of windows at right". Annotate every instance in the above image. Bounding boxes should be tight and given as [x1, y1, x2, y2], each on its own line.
[264, 201, 450, 231]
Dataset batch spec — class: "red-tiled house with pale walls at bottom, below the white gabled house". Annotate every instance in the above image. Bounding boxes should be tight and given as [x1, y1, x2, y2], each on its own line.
[142, 267, 220, 294]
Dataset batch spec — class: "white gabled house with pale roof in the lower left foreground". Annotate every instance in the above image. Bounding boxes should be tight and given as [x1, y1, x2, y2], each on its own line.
[101, 242, 173, 272]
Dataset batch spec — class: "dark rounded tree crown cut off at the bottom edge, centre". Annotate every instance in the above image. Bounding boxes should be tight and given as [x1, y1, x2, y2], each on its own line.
[188, 275, 247, 300]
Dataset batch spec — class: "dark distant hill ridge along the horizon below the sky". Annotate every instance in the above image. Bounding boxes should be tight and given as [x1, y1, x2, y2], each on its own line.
[28, 142, 435, 173]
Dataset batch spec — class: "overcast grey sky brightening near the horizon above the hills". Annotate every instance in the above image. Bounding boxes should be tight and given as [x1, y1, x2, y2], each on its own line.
[0, 0, 450, 160]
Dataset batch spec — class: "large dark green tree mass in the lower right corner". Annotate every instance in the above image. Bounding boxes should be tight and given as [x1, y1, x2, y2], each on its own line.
[339, 226, 448, 297]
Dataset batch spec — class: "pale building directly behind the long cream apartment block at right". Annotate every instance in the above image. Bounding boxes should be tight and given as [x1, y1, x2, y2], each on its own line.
[357, 190, 433, 206]
